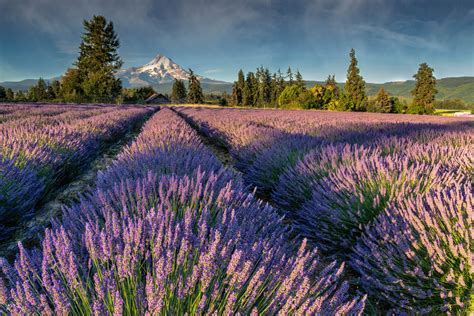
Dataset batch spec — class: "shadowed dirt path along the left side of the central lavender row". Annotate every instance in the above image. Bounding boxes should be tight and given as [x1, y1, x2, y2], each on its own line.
[0, 112, 155, 260]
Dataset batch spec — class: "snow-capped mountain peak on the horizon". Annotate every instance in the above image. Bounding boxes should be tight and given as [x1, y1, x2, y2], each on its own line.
[117, 54, 214, 87]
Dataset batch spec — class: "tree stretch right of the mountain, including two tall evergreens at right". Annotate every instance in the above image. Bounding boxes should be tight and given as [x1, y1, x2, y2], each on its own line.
[231, 49, 437, 114]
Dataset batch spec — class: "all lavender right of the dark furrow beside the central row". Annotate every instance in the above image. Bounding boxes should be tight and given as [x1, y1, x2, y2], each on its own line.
[179, 108, 474, 314]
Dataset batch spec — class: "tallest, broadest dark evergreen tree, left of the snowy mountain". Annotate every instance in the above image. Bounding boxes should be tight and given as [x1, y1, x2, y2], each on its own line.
[75, 16, 123, 102]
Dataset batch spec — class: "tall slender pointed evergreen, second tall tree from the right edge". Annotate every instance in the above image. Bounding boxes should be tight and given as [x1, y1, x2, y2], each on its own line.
[344, 48, 367, 111]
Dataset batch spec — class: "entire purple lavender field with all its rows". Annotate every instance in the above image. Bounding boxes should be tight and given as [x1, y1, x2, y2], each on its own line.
[0, 104, 474, 315]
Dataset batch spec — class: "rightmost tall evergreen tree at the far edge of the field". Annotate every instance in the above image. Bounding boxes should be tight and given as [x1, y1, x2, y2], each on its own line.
[408, 63, 438, 114]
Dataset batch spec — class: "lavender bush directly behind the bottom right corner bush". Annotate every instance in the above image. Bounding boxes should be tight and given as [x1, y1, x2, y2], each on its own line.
[295, 156, 464, 254]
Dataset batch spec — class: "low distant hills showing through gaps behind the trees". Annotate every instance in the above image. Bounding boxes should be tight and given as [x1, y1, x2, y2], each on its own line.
[0, 77, 474, 103]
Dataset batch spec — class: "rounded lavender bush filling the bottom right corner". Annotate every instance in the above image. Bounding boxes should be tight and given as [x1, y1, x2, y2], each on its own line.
[351, 183, 474, 315]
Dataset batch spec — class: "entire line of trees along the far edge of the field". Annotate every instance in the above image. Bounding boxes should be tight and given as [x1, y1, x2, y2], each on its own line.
[0, 16, 452, 114]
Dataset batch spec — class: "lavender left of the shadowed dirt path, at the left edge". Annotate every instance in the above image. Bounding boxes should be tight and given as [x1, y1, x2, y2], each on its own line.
[0, 105, 148, 233]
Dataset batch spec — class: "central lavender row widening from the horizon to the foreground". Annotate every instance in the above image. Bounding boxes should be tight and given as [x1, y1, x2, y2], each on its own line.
[0, 109, 365, 315]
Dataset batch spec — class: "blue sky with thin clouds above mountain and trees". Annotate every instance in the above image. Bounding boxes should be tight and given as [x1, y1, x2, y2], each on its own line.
[0, 0, 474, 82]
